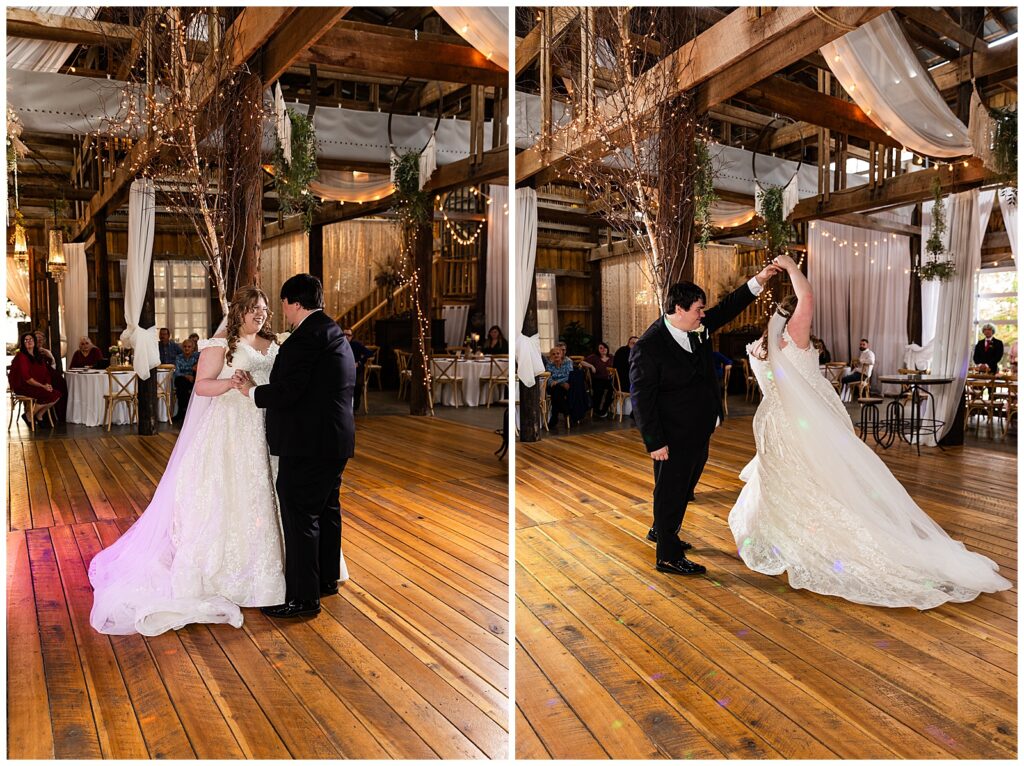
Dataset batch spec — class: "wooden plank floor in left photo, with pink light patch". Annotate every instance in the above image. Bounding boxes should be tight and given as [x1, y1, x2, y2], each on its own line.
[7, 416, 510, 759]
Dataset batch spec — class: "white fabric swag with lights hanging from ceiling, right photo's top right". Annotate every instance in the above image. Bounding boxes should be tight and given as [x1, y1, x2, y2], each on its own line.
[820, 12, 974, 157]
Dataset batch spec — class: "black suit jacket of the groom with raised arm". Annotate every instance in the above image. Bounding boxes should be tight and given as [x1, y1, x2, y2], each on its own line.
[630, 285, 755, 453]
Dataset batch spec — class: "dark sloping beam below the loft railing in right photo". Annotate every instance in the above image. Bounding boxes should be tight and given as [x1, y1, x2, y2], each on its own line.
[790, 160, 997, 223]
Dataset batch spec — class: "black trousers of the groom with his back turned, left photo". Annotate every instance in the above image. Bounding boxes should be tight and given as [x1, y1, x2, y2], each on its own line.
[276, 456, 348, 601]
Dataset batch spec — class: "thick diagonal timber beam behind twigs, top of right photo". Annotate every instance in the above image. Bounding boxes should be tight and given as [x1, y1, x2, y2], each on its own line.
[516, 6, 887, 183]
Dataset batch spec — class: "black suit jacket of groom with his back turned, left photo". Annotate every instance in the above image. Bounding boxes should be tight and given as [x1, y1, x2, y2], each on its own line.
[252, 311, 355, 458]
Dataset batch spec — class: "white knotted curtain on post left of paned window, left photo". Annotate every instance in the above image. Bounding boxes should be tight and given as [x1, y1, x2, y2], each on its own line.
[121, 178, 160, 380]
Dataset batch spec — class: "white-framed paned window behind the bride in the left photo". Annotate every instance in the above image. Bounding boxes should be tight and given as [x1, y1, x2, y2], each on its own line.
[153, 260, 210, 342]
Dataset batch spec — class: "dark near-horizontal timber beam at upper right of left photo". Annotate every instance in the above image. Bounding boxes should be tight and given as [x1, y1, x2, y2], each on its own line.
[296, 23, 508, 87]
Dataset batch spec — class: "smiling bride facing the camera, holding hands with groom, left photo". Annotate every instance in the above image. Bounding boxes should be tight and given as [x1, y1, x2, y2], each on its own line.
[89, 287, 347, 636]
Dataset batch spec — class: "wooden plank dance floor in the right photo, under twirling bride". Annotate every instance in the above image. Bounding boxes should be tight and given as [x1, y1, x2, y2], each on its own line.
[515, 417, 1017, 759]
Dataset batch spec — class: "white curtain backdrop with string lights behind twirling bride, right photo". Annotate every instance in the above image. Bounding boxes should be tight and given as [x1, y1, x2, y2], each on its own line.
[807, 212, 910, 383]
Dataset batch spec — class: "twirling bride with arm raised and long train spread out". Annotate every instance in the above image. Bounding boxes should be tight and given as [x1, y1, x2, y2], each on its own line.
[729, 255, 1013, 609]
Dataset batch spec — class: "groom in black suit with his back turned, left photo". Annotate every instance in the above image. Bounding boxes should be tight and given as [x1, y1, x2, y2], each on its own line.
[236, 274, 355, 618]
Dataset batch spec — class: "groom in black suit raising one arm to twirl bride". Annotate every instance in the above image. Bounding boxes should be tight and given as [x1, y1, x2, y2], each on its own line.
[630, 264, 781, 575]
